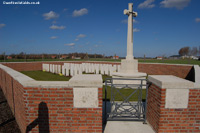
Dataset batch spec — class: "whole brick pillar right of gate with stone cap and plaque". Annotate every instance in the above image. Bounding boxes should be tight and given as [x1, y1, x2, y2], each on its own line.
[147, 75, 200, 132]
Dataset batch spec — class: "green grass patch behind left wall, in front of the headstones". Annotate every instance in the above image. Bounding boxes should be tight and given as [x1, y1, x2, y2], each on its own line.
[21, 71, 71, 81]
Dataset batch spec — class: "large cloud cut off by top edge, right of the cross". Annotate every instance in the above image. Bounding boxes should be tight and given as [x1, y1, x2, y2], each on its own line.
[160, 0, 191, 10]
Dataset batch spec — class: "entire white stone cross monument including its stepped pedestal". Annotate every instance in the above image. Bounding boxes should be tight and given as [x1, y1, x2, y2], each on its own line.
[113, 3, 147, 84]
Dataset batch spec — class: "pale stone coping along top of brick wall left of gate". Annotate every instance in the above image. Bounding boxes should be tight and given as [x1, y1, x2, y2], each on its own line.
[0, 64, 103, 88]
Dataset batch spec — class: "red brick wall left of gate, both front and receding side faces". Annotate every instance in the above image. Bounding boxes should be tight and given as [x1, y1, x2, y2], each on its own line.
[0, 66, 102, 133]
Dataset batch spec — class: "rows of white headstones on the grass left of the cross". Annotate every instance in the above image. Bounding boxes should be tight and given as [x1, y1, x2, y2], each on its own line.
[42, 63, 120, 76]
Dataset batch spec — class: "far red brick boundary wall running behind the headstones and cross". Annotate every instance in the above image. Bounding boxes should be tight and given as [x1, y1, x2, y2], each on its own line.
[2, 61, 193, 79]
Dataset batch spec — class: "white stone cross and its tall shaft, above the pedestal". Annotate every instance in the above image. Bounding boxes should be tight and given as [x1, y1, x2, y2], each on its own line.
[124, 3, 137, 60]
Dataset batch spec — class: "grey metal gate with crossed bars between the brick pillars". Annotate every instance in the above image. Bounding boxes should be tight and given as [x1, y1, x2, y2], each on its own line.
[104, 78, 148, 123]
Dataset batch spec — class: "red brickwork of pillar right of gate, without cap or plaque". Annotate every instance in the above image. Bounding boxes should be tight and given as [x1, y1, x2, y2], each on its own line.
[147, 84, 200, 133]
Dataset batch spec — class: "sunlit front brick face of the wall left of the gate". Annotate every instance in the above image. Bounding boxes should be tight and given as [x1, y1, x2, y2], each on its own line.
[25, 88, 102, 132]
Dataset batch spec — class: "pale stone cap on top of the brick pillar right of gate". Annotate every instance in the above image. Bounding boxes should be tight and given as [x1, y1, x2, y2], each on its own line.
[148, 75, 194, 89]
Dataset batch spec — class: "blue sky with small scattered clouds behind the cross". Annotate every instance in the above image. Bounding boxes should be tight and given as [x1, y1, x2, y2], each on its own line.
[0, 0, 200, 57]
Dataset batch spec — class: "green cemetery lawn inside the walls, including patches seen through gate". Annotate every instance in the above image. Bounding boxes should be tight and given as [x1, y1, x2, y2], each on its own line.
[21, 71, 146, 101]
